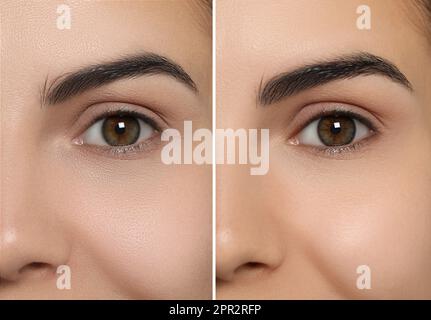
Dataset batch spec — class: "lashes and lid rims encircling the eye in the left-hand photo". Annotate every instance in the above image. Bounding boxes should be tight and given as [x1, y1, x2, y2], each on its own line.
[74, 104, 163, 158]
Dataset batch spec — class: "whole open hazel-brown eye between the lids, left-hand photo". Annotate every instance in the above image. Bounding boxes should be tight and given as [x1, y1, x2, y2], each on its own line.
[79, 113, 158, 147]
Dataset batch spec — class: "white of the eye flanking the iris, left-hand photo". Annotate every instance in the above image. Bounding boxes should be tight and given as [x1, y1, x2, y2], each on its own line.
[82, 118, 155, 146]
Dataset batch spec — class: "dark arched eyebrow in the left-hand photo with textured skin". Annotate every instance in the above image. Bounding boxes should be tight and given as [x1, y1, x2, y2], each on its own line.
[42, 53, 197, 105]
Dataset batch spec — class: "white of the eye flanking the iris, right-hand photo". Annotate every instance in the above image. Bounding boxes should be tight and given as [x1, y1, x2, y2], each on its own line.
[296, 118, 371, 146]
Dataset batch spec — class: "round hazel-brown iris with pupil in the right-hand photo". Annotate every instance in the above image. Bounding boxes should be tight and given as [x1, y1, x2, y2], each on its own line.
[317, 116, 356, 146]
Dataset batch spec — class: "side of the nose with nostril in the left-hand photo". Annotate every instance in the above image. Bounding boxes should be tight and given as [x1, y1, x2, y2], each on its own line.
[0, 139, 70, 281]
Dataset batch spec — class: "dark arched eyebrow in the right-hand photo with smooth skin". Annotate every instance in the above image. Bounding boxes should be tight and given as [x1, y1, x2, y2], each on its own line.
[258, 52, 412, 106]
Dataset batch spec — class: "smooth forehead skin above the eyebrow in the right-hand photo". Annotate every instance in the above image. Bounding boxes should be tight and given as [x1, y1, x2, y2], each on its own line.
[217, 0, 430, 109]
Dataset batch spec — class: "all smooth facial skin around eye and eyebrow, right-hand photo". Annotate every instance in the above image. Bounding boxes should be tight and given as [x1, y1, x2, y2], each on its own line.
[217, 0, 431, 299]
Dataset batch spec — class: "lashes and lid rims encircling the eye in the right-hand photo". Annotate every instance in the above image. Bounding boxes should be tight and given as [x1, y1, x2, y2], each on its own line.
[289, 109, 380, 157]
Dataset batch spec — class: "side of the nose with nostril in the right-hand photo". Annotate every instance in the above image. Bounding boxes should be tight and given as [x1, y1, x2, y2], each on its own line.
[216, 169, 284, 282]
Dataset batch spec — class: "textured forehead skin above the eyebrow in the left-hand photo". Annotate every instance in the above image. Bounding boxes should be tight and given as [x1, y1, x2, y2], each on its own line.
[2, 1, 211, 107]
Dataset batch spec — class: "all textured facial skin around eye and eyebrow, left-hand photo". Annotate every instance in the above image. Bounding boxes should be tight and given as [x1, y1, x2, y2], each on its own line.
[0, 1, 211, 299]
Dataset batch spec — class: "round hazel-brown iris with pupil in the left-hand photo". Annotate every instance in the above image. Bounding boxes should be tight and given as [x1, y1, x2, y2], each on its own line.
[102, 116, 141, 146]
